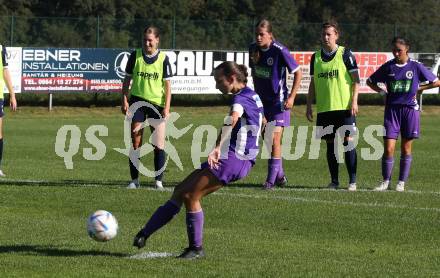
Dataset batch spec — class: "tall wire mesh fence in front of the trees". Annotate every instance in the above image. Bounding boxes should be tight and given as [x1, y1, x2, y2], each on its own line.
[0, 16, 440, 52]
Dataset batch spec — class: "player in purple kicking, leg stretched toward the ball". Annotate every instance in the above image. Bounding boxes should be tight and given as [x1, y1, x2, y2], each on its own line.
[133, 62, 263, 259]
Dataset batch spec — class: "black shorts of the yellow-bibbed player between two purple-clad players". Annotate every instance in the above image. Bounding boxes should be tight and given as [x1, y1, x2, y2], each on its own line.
[316, 110, 357, 140]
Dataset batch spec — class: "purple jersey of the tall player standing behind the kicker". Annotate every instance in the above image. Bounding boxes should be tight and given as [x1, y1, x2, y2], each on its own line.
[249, 41, 299, 112]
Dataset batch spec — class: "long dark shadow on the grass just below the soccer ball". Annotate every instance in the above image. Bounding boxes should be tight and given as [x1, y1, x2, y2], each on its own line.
[0, 245, 127, 258]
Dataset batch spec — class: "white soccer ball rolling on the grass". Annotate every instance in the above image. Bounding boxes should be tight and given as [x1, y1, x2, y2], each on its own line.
[87, 210, 118, 241]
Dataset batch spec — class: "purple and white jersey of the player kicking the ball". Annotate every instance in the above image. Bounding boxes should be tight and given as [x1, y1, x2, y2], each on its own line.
[229, 87, 263, 162]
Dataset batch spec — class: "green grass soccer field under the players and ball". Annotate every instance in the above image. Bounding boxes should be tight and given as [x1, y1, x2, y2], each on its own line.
[0, 106, 440, 277]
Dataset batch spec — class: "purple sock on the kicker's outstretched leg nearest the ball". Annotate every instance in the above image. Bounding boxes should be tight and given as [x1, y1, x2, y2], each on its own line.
[141, 200, 180, 238]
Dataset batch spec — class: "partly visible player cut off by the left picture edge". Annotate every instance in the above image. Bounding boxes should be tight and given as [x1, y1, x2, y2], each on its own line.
[0, 44, 17, 177]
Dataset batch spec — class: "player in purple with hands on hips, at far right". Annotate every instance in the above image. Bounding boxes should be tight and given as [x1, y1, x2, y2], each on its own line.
[367, 37, 440, 191]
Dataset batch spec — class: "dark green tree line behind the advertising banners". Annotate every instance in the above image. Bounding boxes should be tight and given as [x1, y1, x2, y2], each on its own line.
[0, 0, 440, 52]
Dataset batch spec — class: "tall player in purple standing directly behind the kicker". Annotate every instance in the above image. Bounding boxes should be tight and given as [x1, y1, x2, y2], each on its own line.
[249, 19, 302, 190]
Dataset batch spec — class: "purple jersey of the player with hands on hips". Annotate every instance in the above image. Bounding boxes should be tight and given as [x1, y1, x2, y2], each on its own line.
[369, 59, 437, 107]
